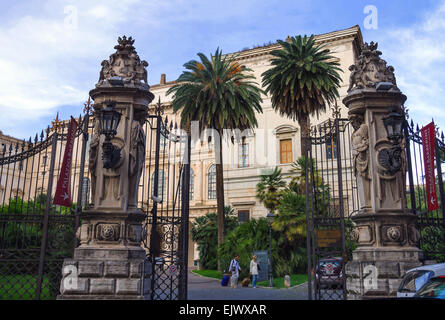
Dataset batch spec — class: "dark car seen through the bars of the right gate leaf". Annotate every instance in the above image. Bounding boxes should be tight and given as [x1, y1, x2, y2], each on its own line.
[315, 257, 343, 289]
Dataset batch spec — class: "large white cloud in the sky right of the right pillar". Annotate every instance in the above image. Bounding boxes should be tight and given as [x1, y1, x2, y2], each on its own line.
[382, 0, 445, 129]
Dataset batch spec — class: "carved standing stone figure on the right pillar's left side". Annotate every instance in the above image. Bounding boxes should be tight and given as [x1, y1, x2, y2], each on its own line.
[349, 114, 371, 209]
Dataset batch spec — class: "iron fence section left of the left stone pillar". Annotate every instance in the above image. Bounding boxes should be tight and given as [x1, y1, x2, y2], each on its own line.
[0, 115, 89, 300]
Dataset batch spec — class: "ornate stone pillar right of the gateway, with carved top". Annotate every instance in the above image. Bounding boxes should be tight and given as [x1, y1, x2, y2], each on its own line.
[343, 42, 421, 299]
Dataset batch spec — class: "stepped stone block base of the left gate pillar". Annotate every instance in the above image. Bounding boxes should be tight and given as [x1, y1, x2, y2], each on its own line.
[57, 248, 151, 300]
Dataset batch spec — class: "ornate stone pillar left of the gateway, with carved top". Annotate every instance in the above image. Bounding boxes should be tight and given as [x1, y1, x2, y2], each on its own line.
[58, 36, 154, 299]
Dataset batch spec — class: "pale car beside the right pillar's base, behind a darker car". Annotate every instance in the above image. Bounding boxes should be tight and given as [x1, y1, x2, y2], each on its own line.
[397, 263, 445, 298]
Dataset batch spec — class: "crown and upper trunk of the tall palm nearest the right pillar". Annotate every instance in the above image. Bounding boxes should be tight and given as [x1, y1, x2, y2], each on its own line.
[262, 35, 342, 156]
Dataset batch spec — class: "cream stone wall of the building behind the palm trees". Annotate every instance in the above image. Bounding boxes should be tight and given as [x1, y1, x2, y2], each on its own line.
[147, 26, 362, 265]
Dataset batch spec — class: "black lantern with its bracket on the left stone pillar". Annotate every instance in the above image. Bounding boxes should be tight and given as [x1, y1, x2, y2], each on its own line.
[99, 101, 121, 169]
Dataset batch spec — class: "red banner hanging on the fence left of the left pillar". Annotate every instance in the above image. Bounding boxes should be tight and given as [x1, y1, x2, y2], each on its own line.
[53, 117, 77, 207]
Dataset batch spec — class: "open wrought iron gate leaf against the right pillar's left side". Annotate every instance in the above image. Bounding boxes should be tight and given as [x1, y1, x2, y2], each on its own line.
[306, 118, 359, 300]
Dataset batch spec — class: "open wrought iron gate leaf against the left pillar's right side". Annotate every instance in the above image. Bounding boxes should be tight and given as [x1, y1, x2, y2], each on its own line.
[140, 102, 190, 300]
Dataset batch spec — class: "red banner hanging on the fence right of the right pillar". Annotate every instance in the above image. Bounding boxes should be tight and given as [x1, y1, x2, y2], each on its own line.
[421, 122, 439, 211]
